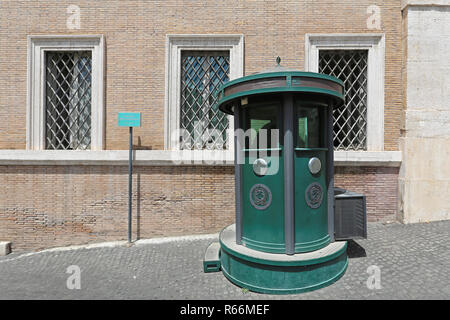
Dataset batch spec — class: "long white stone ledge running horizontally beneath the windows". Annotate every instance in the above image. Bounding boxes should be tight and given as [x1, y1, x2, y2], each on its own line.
[0, 150, 402, 167]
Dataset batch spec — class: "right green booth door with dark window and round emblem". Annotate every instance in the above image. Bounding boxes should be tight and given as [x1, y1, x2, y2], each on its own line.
[294, 99, 330, 252]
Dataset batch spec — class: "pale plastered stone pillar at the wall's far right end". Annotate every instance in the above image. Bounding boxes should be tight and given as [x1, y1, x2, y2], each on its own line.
[399, 1, 450, 223]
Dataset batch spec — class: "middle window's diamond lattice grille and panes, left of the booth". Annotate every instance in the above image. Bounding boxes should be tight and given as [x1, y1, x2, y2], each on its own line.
[180, 51, 230, 150]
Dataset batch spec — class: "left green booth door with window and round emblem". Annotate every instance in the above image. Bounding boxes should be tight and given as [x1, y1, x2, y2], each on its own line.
[242, 97, 285, 253]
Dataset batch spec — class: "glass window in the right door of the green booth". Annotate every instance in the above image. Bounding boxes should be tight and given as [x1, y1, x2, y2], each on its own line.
[294, 101, 326, 149]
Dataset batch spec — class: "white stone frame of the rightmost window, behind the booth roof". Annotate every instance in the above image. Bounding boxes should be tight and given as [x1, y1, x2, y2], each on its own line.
[305, 33, 385, 152]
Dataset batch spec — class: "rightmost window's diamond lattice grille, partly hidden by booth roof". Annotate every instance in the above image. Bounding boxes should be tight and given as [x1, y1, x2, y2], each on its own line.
[319, 50, 368, 150]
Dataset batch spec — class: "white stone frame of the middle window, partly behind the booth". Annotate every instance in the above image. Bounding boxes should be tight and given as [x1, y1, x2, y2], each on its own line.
[164, 34, 244, 156]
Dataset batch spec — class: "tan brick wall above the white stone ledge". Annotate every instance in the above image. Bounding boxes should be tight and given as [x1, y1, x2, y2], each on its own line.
[0, 0, 402, 150]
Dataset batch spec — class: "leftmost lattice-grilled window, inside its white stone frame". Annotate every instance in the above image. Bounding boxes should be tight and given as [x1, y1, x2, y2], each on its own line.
[45, 51, 92, 150]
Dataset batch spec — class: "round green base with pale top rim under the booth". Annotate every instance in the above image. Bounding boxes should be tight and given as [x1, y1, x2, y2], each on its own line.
[220, 224, 348, 294]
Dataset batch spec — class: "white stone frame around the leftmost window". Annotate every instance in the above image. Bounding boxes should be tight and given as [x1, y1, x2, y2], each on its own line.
[26, 35, 105, 152]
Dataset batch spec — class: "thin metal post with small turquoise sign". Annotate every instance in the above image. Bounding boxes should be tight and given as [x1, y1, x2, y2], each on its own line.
[118, 112, 141, 243]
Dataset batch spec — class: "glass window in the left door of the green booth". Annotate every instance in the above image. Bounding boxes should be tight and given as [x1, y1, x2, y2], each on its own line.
[243, 100, 281, 149]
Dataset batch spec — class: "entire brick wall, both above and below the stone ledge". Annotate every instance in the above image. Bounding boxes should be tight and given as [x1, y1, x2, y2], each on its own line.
[0, 0, 402, 249]
